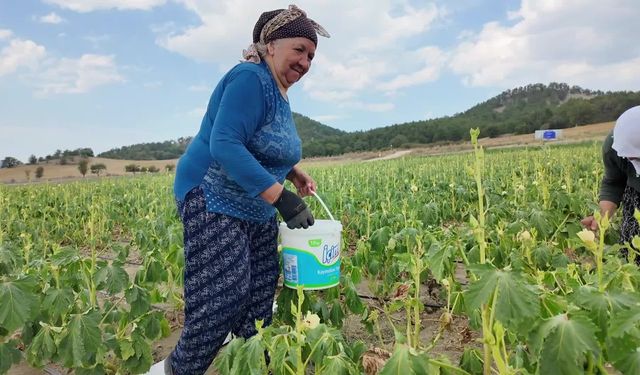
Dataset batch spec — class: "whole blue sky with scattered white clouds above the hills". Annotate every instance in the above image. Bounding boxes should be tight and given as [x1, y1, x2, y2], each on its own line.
[0, 0, 640, 162]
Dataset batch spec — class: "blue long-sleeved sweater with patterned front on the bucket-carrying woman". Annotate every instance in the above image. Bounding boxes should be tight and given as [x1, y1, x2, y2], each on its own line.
[174, 62, 301, 221]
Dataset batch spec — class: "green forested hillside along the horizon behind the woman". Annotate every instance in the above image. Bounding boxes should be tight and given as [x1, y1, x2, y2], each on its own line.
[98, 83, 640, 160]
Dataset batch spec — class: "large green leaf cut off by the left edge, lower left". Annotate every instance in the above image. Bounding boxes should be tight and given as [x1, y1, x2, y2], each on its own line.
[0, 277, 40, 332]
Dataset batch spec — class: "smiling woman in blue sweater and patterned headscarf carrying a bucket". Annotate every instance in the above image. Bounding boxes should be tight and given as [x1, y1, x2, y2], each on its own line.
[165, 5, 329, 374]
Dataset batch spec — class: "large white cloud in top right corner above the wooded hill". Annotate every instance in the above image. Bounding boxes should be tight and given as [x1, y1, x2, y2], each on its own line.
[450, 0, 640, 90]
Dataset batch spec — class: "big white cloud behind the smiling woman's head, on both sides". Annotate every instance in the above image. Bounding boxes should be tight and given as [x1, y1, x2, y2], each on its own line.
[156, 0, 445, 111]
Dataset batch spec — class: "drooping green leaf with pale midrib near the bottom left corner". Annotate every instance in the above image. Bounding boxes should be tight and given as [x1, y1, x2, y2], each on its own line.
[58, 311, 102, 368]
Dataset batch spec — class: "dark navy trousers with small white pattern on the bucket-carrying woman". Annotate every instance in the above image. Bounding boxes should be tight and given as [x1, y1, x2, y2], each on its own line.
[169, 188, 279, 375]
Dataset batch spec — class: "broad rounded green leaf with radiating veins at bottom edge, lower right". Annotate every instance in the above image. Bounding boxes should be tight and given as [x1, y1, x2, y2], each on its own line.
[532, 314, 600, 375]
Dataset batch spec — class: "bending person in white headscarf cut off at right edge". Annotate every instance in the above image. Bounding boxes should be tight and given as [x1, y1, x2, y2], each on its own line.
[582, 106, 640, 264]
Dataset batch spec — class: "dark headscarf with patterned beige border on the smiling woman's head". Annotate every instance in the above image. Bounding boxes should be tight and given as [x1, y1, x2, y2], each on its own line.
[242, 5, 330, 63]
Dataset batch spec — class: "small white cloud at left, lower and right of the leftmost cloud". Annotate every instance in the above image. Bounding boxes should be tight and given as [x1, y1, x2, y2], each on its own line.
[35, 54, 124, 96]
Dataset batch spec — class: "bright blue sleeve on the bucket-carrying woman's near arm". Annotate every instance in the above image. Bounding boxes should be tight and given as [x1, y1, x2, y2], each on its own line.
[209, 71, 276, 197]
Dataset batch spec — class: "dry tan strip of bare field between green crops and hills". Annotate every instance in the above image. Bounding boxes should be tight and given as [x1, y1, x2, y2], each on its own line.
[0, 122, 614, 184]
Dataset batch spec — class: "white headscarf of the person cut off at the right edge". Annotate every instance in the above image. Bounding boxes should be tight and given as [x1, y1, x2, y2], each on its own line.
[611, 106, 640, 175]
